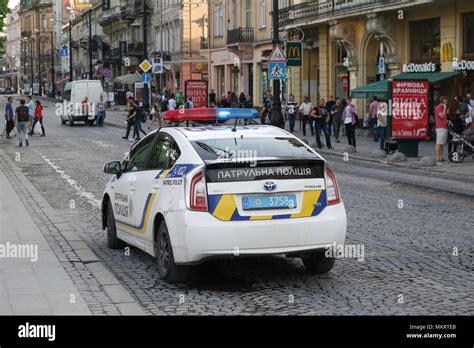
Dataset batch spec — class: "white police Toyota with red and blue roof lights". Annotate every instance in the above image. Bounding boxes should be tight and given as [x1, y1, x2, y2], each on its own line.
[102, 109, 346, 282]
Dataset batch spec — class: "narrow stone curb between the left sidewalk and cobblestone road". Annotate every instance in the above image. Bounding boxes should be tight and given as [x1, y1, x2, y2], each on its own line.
[0, 149, 146, 315]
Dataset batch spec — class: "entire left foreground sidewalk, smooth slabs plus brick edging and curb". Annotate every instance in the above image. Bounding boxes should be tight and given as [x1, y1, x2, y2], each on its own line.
[0, 149, 146, 315]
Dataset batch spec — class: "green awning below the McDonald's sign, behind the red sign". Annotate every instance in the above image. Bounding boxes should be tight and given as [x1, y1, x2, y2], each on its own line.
[351, 71, 461, 99]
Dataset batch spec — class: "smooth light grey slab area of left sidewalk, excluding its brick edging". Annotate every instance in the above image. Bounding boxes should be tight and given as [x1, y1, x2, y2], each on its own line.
[0, 160, 91, 315]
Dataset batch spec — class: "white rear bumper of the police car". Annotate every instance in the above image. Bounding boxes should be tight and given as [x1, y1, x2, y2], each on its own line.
[173, 203, 347, 263]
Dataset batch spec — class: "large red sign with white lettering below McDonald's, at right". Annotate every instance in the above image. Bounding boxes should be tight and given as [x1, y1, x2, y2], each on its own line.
[392, 80, 429, 139]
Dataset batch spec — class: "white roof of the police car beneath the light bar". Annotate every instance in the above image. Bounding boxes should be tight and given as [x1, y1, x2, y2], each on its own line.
[168, 124, 293, 141]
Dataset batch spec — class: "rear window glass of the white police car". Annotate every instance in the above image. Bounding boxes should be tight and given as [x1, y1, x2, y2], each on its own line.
[191, 136, 319, 162]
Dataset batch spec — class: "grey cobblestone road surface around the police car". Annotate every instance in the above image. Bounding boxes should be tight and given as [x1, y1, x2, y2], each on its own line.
[0, 98, 474, 315]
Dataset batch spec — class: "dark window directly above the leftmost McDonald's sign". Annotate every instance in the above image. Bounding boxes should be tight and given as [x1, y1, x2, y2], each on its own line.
[410, 18, 441, 62]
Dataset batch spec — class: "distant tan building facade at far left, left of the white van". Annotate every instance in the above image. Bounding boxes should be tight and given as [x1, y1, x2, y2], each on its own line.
[19, 0, 54, 94]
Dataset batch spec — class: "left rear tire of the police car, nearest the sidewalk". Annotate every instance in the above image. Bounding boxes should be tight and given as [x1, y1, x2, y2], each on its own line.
[154, 221, 187, 283]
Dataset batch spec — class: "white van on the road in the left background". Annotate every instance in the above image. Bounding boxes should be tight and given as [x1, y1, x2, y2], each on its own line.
[61, 80, 105, 127]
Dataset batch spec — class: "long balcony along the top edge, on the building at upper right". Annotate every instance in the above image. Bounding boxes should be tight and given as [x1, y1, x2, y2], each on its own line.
[279, 0, 426, 26]
